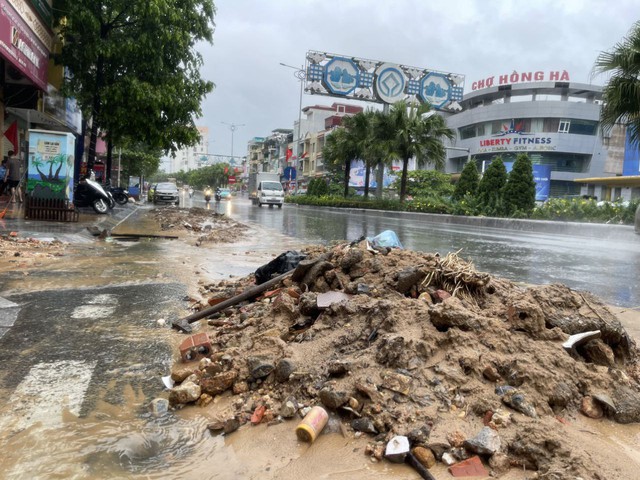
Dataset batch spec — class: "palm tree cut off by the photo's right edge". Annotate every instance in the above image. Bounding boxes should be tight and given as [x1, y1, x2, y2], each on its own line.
[594, 22, 640, 146]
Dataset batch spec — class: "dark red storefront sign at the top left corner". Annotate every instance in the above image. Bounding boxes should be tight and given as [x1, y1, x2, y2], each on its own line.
[0, 0, 49, 91]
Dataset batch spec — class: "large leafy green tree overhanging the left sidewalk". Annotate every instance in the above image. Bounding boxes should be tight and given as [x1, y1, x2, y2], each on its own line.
[54, 0, 215, 172]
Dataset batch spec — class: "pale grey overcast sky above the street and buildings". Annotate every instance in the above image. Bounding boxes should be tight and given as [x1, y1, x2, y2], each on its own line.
[196, 0, 640, 161]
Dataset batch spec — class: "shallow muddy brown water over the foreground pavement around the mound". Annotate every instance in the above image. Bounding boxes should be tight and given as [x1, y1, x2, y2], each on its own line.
[0, 211, 640, 480]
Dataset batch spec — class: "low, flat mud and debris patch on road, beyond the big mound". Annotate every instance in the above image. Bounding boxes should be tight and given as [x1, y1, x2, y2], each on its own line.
[153, 207, 247, 246]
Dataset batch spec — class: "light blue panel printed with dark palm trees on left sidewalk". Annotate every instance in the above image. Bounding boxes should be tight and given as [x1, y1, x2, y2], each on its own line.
[27, 130, 76, 201]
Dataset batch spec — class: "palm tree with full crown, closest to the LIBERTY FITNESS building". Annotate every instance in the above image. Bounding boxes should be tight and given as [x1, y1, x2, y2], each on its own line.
[385, 101, 454, 202]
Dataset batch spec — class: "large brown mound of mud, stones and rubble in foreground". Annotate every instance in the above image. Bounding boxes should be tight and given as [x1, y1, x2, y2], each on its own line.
[169, 241, 640, 479]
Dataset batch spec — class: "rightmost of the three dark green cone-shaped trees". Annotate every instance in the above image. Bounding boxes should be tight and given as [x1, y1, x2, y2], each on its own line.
[504, 153, 536, 217]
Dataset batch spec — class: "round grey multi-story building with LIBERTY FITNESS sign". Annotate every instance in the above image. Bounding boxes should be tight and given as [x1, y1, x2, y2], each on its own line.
[446, 72, 632, 200]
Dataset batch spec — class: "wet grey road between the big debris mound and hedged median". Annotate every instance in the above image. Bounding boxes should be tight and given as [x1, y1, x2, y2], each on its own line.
[218, 197, 640, 307]
